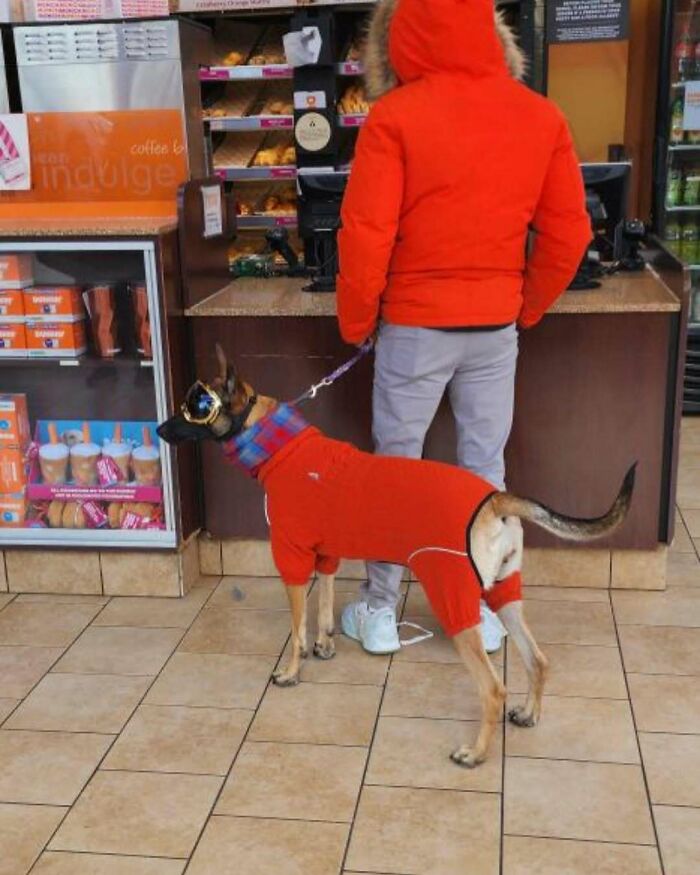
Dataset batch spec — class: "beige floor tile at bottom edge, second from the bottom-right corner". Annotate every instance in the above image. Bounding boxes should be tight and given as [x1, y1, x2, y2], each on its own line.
[503, 836, 660, 875]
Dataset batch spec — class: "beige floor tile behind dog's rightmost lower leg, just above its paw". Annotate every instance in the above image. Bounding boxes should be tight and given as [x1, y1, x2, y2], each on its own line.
[507, 642, 627, 699]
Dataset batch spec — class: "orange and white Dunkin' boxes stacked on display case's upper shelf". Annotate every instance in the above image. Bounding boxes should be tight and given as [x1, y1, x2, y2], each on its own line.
[0, 255, 87, 358]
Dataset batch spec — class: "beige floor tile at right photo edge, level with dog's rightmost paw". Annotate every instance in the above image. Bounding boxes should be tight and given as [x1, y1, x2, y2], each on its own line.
[627, 674, 700, 733]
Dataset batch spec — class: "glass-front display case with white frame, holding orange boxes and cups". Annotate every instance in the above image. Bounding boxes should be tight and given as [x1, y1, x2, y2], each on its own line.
[0, 238, 178, 548]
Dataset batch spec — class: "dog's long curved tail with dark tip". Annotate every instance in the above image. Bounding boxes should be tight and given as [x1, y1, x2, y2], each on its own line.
[492, 462, 637, 541]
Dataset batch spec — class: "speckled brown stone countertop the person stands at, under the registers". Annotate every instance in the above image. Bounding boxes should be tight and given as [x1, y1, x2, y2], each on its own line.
[186, 268, 680, 316]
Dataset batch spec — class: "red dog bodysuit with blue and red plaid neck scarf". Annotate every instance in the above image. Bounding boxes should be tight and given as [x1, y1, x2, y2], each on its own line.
[224, 404, 521, 636]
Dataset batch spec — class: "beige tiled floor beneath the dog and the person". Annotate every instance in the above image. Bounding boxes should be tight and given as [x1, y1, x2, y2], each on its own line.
[0, 420, 700, 875]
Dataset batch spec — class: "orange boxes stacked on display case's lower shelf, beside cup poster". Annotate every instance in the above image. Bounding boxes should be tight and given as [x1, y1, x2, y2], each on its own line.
[0, 395, 30, 528]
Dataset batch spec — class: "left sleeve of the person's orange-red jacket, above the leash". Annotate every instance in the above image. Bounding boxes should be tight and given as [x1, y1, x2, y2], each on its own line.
[337, 103, 404, 343]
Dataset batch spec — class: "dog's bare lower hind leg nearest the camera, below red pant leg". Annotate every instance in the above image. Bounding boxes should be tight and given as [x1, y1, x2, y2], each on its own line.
[451, 626, 506, 768]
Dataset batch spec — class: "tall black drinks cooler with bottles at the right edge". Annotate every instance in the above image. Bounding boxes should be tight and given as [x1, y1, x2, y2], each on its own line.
[654, 0, 700, 413]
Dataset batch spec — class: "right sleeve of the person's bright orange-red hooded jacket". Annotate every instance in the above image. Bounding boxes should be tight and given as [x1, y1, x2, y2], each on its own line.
[518, 119, 593, 328]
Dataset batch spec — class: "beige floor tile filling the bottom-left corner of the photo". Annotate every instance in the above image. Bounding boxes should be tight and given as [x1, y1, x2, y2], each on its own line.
[0, 804, 66, 875]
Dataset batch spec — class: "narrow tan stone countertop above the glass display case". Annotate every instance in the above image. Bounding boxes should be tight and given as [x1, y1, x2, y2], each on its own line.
[0, 216, 177, 238]
